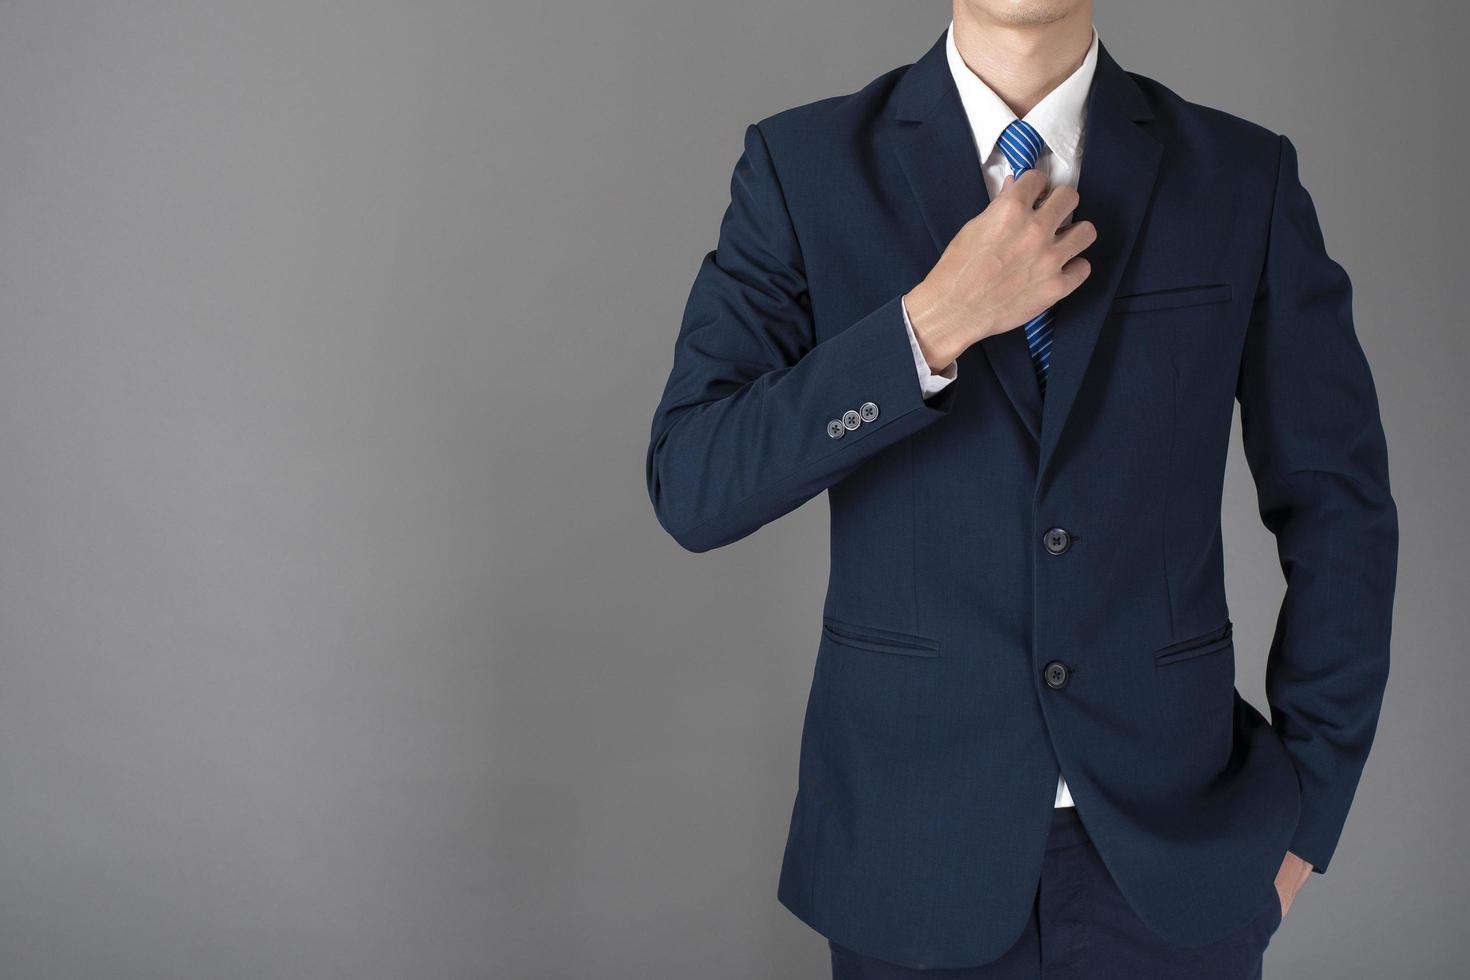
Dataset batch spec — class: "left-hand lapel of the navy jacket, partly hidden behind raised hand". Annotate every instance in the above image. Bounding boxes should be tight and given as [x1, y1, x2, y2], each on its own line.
[894, 35, 1041, 442]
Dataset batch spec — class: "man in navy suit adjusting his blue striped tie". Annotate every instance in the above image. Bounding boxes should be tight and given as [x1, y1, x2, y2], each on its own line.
[647, 0, 1398, 980]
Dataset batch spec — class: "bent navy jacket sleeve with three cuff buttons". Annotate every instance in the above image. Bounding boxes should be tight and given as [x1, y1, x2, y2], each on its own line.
[645, 125, 953, 551]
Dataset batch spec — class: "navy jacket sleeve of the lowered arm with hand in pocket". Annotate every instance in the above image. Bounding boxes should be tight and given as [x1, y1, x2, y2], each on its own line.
[1236, 135, 1398, 873]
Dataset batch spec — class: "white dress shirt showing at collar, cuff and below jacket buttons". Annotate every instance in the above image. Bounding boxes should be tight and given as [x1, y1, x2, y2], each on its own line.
[900, 22, 1098, 807]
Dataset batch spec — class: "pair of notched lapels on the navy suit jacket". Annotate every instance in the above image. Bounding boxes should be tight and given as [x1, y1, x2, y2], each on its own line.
[894, 35, 1163, 476]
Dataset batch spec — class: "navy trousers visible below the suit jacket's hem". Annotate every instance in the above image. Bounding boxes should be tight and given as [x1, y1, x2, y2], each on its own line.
[828, 807, 1285, 980]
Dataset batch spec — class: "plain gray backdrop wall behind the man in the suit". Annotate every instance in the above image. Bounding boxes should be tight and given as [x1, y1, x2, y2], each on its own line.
[0, 0, 1470, 980]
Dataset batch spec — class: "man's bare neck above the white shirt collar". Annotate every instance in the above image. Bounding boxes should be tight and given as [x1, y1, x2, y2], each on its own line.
[954, 0, 1092, 118]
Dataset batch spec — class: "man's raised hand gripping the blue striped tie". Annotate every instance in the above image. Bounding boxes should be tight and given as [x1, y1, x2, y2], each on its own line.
[904, 167, 1097, 370]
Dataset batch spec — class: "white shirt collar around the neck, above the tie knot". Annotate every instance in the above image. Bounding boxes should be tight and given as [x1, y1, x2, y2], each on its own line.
[944, 21, 1098, 166]
